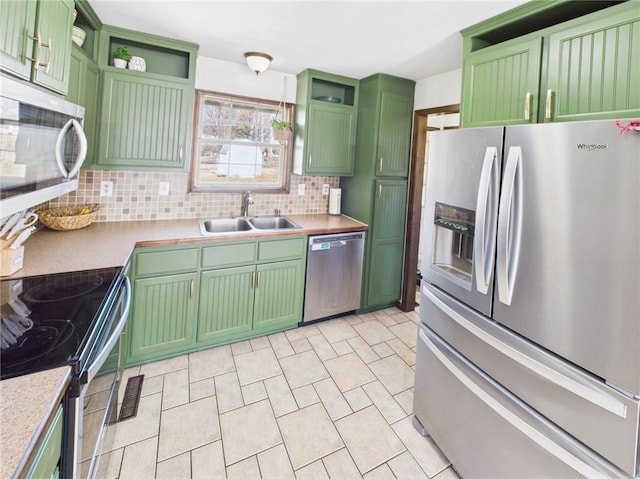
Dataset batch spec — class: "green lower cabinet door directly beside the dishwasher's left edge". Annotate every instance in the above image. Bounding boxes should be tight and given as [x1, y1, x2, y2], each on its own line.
[253, 260, 305, 332]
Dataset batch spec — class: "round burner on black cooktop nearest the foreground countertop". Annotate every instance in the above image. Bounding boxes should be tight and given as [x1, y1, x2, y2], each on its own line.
[2, 319, 74, 369]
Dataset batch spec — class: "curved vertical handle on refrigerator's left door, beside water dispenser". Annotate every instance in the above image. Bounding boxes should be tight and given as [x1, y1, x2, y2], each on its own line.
[473, 146, 500, 294]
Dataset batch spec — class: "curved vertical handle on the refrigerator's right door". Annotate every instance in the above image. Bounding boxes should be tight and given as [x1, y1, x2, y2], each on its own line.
[496, 146, 522, 306]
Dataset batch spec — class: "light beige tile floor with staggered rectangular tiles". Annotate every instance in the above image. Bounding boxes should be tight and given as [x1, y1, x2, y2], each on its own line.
[99, 308, 458, 479]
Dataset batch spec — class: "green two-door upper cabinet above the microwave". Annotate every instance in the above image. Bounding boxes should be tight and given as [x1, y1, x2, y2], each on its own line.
[0, 0, 74, 95]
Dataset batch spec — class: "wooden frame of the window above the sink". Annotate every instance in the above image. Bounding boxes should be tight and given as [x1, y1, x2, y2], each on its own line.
[189, 89, 295, 193]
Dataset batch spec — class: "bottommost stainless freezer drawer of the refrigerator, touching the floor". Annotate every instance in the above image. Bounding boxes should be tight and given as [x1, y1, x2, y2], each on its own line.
[414, 325, 629, 479]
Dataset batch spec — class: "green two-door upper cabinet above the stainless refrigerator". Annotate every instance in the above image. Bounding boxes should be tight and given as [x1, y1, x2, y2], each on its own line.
[461, 1, 640, 128]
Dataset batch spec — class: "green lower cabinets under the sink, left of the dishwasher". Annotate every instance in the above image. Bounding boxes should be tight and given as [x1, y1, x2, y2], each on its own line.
[126, 235, 306, 366]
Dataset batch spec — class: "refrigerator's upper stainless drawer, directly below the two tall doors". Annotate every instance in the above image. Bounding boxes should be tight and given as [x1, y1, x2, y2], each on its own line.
[422, 283, 640, 477]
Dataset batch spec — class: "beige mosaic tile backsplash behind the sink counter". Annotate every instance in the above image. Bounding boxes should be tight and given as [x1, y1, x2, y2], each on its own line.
[50, 170, 340, 221]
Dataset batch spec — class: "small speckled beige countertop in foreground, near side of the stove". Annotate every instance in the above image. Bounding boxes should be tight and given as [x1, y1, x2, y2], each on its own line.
[0, 367, 71, 478]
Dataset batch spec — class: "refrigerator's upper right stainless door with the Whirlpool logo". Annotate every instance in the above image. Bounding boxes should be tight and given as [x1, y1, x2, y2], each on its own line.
[493, 121, 640, 397]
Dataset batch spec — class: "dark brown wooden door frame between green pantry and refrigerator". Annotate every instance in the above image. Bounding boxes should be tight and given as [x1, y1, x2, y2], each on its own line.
[398, 103, 460, 312]
